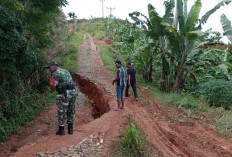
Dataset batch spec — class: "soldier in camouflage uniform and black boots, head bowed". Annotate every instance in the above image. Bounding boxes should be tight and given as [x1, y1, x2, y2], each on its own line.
[47, 60, 77, 135]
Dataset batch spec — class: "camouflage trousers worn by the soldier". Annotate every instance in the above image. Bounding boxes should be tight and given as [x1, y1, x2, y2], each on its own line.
[56, 89, 77, 126]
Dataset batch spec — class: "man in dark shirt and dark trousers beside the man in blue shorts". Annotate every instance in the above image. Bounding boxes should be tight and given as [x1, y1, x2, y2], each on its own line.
[125, 62, 138, 101]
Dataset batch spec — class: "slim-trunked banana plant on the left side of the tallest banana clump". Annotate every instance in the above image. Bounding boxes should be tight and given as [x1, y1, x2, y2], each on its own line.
[129, 0, 175, 89]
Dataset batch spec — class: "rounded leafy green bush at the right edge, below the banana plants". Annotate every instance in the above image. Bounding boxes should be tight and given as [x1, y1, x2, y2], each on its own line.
[197, 80, 232, 109]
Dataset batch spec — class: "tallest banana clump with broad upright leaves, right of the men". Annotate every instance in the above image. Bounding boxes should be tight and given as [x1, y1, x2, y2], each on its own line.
[131, 0, 231, 91]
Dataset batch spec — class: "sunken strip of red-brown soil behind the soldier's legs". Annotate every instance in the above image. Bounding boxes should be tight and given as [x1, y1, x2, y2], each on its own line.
[0, 98, 94, 157]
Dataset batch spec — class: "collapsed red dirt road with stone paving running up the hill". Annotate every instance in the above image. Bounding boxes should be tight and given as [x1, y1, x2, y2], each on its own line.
[3, 33, 232, 157]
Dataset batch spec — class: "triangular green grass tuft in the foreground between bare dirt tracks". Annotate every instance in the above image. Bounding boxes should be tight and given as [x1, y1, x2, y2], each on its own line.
[112, 116, 154, 157]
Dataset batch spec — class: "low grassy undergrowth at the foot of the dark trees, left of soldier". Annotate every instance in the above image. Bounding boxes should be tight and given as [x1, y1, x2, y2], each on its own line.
[0, 88, 56, 141]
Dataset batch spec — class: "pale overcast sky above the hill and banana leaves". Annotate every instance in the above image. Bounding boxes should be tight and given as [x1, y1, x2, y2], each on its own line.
[63, 0, 232, 42]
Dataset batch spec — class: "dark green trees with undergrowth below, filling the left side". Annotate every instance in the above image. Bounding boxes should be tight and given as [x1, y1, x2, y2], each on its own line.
[0, 0, 67, 142]
